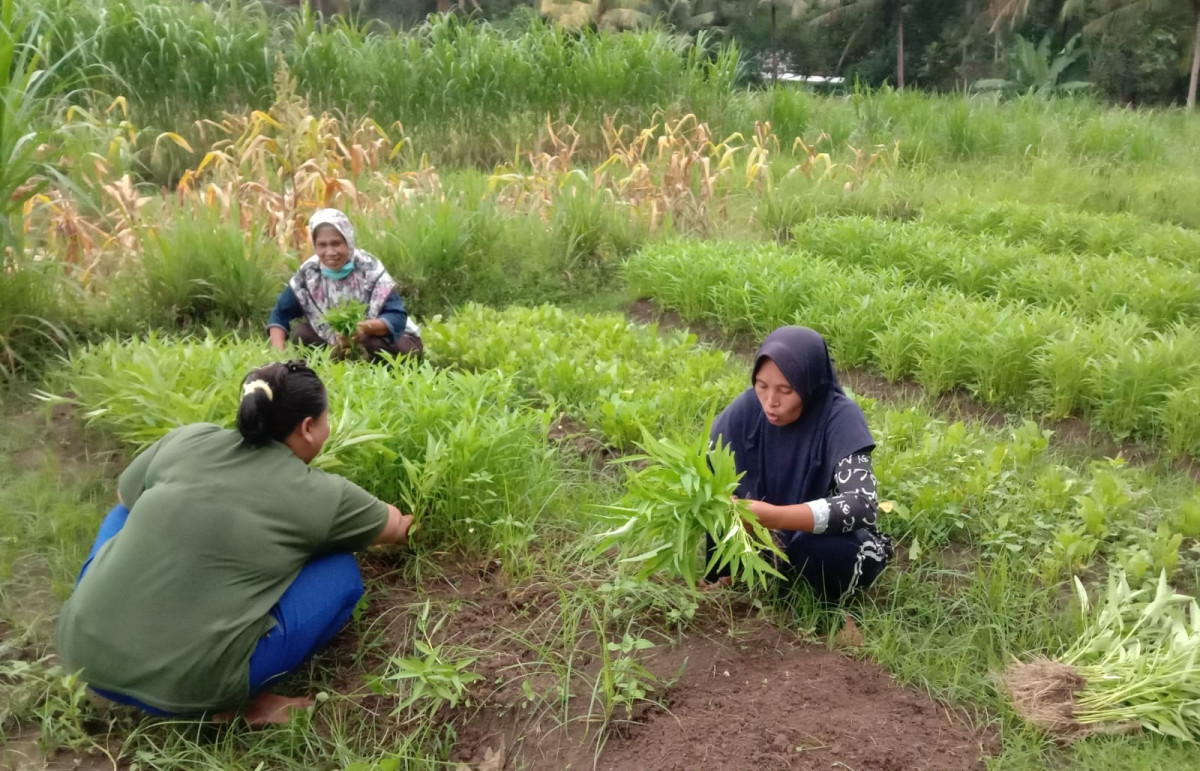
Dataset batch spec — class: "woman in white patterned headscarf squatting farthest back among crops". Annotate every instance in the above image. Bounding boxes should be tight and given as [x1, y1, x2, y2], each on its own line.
[266, 209, 424, 358]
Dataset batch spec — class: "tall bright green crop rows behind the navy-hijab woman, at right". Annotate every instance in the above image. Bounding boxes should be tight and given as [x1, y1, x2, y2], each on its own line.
[625, 229, 1200, 456]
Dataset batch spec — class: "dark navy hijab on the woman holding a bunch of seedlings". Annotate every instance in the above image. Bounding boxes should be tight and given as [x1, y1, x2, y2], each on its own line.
[713, 327, 875, 506]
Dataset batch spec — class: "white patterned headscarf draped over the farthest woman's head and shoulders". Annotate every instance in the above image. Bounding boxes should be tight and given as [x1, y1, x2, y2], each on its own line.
[288, 209, 396, 345]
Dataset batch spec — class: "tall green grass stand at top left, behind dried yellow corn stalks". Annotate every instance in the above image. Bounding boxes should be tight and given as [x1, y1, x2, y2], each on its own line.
[14, 0, 737, 157]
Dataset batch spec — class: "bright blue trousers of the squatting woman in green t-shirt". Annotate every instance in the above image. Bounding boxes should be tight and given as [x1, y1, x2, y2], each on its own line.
[76, 503, 362, 717]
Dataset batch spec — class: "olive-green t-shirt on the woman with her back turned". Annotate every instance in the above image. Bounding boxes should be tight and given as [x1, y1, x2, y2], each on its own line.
[58, 424, 388, 712]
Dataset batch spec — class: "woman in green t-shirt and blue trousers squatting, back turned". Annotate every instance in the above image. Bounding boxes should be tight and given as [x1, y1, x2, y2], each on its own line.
[58, 361, 413, 725]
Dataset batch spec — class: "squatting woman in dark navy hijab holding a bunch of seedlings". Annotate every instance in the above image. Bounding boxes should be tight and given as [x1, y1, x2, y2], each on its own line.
[708, 327, 893, 600]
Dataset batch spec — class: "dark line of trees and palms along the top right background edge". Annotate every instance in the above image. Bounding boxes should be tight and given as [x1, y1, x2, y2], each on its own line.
[321, 0, 1200, 107]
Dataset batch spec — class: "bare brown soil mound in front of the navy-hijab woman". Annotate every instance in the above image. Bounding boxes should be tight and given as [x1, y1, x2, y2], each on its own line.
[457, 622, 990, 771]
